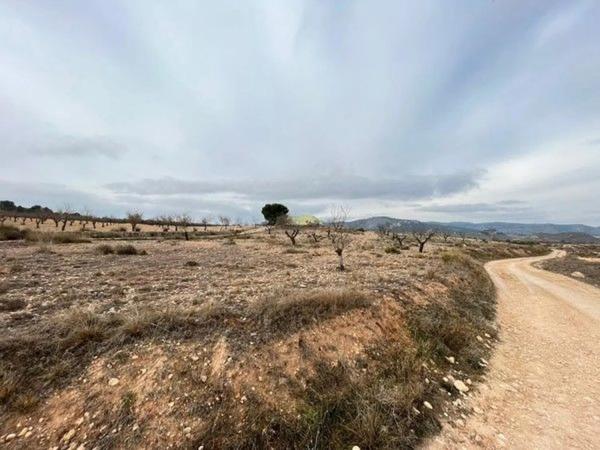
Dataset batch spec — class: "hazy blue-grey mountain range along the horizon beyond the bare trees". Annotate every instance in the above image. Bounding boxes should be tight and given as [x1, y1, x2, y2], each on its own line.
[348, 216, 600, 238]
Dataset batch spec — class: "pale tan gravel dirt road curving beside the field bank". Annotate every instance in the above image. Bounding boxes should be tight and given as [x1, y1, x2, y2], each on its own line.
[425, 251, 600, 449]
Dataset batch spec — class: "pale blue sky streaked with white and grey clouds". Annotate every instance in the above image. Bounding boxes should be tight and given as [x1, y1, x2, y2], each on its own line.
[0, 0, 600, 225]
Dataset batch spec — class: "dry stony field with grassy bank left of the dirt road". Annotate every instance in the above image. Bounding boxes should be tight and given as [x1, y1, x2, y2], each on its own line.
[0, 227, 544, 449]
